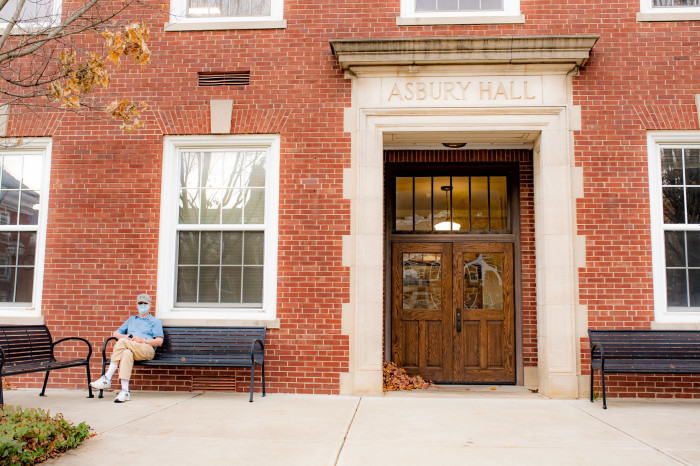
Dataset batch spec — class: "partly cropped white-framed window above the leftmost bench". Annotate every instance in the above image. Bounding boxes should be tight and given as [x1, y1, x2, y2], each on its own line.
[0, 138, 51, 316]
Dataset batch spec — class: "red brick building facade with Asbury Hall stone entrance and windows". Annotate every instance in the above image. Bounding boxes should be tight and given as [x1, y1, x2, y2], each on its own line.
[0, 0, 700, 398]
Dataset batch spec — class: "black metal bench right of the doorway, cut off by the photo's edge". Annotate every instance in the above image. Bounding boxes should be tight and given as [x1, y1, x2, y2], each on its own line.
[588, 330, 700, 409]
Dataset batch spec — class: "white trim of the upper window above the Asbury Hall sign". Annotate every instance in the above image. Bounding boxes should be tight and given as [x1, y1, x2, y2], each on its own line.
[396, 0, 525, 26]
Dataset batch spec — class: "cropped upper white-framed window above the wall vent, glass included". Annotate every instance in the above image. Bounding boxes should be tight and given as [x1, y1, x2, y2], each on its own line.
[165, 0, 287, 31]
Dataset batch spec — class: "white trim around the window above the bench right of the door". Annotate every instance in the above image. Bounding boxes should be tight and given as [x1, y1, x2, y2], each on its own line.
[647, 131, 700, 323]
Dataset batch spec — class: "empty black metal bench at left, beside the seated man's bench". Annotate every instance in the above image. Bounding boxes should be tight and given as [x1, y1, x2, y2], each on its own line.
[0, 325, 93, 405]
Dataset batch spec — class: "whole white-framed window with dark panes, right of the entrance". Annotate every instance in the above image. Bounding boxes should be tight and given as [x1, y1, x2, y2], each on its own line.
[648, 131, 700, 322]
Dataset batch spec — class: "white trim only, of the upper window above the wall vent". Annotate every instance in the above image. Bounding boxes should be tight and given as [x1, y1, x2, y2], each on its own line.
[165, 0, 287, 32]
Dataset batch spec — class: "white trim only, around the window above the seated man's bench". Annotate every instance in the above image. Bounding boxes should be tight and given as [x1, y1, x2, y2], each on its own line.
[156, 134, 280, 322]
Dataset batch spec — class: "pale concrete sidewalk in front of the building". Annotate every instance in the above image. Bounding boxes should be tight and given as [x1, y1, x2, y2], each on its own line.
[5, 387, 700, 466]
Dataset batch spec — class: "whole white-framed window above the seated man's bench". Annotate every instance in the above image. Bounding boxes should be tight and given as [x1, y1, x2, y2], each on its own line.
[157, 135, 280, 320]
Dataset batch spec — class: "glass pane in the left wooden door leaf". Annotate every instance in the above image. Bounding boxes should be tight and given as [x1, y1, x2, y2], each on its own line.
[402, 253, 442, 309]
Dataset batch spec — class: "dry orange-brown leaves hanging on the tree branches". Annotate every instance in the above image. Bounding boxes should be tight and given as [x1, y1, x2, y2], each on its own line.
[49, 23, 151, 131]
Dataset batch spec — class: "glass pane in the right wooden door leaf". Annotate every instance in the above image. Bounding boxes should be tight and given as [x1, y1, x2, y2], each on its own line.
[463, 252, 503, 310]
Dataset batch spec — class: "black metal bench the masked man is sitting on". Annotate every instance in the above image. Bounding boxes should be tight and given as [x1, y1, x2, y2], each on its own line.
[99, 327, 267, 402]
